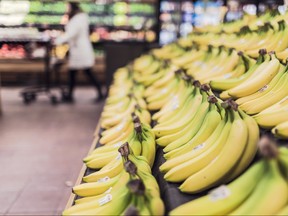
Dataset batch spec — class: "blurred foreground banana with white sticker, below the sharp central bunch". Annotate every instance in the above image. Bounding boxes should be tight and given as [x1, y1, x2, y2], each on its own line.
[169, 161, 265, 216]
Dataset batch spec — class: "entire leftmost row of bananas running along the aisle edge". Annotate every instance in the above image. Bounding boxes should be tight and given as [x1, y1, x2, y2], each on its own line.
[63, 63, 164, 215]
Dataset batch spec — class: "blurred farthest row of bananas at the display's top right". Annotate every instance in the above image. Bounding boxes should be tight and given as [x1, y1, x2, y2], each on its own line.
[190, 19, 288, 59]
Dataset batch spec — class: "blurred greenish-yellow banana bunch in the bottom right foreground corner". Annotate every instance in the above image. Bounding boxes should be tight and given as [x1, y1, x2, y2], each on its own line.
[170, 137, 288, 215]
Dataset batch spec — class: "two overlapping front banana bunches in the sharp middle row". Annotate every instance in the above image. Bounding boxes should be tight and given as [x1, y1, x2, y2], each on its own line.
[153, 78, 259, 194]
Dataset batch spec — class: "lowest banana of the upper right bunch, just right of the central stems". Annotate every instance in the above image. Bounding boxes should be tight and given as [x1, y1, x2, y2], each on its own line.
[228, 55, 280, 98]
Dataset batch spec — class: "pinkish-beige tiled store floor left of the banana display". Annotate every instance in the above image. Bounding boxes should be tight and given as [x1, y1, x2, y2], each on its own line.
[0, 88, 103, 215]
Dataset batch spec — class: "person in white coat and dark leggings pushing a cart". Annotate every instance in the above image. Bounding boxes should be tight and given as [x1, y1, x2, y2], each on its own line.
[54, 2, 103, 102]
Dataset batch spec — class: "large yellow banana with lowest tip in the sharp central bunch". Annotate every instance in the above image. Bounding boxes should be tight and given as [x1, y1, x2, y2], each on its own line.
[179, 111, 248, 193]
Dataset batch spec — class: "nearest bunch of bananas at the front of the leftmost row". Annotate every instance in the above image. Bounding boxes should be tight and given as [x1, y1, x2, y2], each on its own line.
[63, 143, 164, 215]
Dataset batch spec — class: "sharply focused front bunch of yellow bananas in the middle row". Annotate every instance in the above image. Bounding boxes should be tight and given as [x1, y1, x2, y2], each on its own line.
[159, 96, 259, 193]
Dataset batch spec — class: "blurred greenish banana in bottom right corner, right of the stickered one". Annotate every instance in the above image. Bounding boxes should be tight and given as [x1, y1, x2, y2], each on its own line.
[231, 159, 288, 215]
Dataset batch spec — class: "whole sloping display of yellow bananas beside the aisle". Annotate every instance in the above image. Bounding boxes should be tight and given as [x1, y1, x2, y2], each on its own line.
[63, 8, 288, 215]
